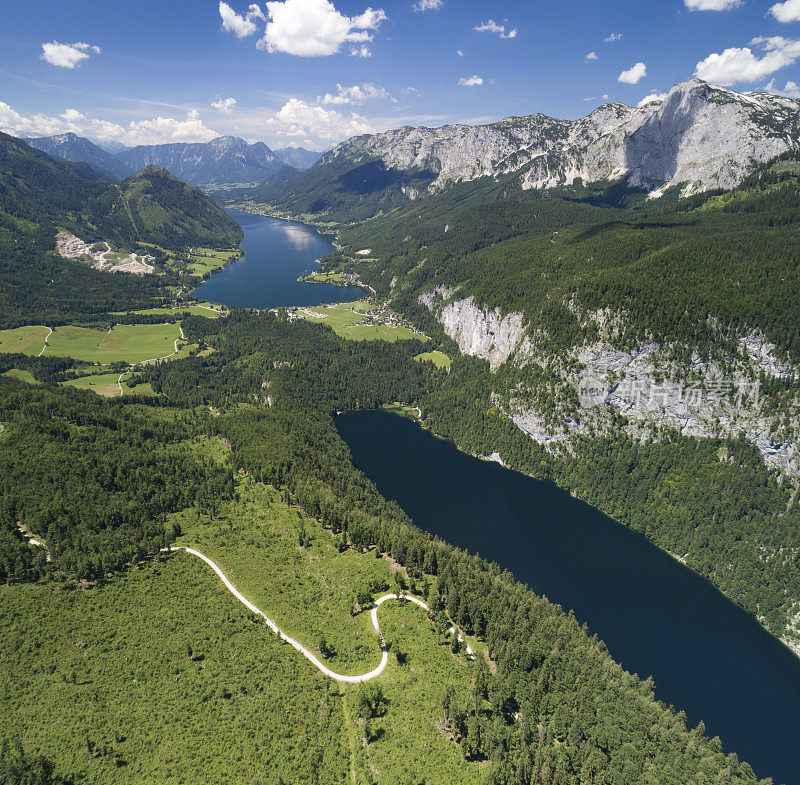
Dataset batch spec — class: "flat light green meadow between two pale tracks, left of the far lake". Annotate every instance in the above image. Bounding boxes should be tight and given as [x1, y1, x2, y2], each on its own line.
[45, 324, 187, 363]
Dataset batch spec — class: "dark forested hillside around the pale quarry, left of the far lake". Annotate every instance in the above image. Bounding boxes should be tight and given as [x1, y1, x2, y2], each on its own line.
[0, 134, 242, 327]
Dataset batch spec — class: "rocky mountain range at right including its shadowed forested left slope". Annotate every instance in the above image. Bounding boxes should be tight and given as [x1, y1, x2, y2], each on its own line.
[245, 79, 800, 218]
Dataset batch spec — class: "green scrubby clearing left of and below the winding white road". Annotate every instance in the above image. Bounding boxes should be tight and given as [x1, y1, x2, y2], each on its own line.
[0, 555, 350, 785]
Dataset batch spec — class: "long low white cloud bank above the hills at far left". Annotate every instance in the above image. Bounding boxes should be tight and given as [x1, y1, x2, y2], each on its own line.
[0, 101, 219, 146]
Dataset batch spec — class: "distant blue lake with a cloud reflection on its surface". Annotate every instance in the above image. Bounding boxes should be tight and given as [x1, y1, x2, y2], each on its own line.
[192, 210, 365, 309]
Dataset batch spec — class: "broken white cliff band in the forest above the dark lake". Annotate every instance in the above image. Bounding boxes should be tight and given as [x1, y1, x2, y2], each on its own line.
[420, 287, 800, 478]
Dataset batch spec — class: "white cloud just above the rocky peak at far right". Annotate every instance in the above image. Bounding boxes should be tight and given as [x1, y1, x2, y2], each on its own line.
[695, 35, 800, 85]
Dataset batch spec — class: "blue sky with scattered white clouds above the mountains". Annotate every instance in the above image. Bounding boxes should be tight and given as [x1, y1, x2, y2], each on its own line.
[0, 0, 800, 150]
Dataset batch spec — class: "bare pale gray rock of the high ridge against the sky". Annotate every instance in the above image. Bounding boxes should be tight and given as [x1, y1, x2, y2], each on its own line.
[322, 79, 800, 198]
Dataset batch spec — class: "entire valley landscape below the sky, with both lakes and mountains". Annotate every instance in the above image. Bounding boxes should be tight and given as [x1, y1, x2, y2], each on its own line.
[0, 70, 800, 785]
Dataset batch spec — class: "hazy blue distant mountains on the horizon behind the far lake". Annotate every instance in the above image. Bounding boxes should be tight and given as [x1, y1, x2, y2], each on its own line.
[25, 133, 321, 187]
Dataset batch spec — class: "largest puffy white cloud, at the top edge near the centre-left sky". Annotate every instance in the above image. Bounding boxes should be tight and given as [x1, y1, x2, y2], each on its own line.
[258, 0, 386, 57]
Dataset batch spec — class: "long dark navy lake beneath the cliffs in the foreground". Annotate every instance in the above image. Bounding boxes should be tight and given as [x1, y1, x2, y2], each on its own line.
[336, 412, 800, 785]
